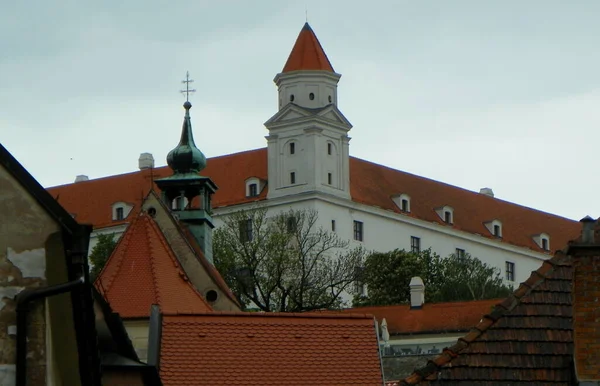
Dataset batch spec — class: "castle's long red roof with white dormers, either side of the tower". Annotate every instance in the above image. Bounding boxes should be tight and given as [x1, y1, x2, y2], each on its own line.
[48, 148, 579, 252]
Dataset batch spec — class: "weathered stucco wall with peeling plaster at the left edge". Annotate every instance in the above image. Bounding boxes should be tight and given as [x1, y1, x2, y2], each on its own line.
[0, 168, 79, 386]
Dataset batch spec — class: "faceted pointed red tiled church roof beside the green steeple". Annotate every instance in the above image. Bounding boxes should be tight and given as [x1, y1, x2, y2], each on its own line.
[95, 213, 211, 318]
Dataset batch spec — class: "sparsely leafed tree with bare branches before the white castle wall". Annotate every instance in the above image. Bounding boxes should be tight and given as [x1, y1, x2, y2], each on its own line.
[213, 208, 365, 312]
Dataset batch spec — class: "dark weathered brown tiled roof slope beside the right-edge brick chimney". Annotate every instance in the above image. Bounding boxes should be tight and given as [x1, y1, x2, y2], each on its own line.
[398, 252, 574, 386]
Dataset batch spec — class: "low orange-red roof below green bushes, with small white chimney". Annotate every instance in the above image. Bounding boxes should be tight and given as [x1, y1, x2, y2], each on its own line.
[342, 299, 503, 334]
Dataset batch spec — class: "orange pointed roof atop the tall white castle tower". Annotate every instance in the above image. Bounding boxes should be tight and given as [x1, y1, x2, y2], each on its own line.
[281, 23, 335, 72]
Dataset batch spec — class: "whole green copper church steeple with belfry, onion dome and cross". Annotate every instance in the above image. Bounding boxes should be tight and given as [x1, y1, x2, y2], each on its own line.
[155, 73, 217, 263]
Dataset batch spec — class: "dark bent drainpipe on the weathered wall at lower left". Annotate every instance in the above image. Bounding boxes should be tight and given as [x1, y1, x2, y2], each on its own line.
[16, 276, 85, 386]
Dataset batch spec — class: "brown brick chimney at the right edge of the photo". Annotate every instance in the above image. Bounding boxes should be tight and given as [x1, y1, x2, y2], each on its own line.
[569, 216, 600, 385]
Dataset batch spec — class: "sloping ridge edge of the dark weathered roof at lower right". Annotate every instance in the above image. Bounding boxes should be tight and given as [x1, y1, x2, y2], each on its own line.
[399, 250, 569, 386]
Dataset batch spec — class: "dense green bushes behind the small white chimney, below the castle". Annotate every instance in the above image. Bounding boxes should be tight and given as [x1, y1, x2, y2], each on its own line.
[354, 249, 512, 306]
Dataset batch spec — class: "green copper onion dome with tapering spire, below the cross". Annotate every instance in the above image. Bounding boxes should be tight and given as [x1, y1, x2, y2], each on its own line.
[167, 102, 206, 174]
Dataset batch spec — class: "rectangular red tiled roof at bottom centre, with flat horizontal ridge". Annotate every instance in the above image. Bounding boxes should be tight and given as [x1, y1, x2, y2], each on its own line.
[160, 312, 382, 386]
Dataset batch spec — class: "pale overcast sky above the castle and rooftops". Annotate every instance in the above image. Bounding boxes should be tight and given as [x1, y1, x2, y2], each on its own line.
[0, 0, 600, 220]
